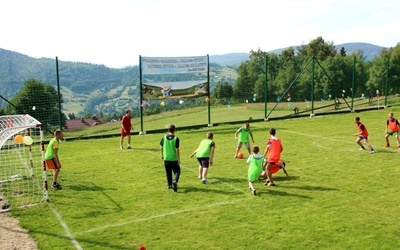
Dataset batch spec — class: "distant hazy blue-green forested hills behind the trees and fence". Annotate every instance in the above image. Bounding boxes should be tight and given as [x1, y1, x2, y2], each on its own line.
[0, 43, 383, 115]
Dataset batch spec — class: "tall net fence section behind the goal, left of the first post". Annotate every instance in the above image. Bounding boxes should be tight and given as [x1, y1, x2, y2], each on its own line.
[0, 57, 64, 132]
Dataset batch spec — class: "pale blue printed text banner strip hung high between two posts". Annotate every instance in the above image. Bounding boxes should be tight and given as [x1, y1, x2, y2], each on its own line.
[141, 56, 208, 75]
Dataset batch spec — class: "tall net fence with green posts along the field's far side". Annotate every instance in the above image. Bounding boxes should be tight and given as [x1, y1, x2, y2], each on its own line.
[0, 53, 400, 136]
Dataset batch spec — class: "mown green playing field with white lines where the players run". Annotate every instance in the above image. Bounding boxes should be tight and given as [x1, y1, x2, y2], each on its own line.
[12, 107, 400, 249]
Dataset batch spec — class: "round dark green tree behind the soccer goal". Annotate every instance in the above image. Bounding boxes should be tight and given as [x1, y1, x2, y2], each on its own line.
[6, 78, 64, 130]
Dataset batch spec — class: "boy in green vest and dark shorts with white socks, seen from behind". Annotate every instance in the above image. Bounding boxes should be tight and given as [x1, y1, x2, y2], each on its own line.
[190, 132, 215, 184]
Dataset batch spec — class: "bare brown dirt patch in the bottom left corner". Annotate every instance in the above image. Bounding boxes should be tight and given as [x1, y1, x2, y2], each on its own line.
[0, 213, 37, 250]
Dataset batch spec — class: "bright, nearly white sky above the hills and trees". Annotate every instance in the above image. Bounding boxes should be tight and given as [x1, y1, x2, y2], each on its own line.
[0, 0, 400, 68]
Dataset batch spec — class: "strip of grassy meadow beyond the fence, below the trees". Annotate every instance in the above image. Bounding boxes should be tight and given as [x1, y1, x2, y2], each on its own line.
[64, 96, 400, 138]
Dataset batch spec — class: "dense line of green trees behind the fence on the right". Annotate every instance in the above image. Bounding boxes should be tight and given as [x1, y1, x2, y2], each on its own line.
[212, 37, 400, 103]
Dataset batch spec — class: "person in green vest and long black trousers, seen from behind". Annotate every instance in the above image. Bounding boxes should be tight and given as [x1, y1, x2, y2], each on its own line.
[160, 124, 181, 192]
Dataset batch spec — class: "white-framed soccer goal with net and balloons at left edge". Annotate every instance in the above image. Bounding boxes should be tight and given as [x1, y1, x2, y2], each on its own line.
[0, 115, 48, 212]
